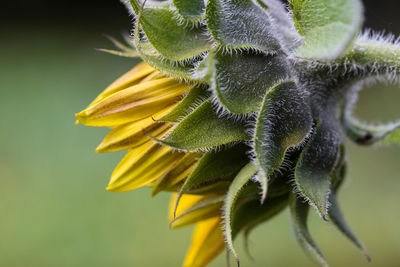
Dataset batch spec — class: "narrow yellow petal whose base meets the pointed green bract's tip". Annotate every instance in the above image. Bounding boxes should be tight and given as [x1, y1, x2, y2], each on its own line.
[96, 105, 174, 153]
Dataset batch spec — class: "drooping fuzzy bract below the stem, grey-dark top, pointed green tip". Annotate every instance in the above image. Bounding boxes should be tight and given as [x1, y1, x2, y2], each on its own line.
[295, 118, 342, 219]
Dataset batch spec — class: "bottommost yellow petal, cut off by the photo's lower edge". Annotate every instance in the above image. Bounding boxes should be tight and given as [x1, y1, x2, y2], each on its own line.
[183, 217, 225, 267]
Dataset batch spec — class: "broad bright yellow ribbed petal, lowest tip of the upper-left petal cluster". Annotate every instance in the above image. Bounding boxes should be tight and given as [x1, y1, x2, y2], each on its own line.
[107, 142, 184, 192]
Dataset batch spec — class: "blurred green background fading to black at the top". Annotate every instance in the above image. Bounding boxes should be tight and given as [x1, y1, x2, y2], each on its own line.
[0, 0, 400, 267]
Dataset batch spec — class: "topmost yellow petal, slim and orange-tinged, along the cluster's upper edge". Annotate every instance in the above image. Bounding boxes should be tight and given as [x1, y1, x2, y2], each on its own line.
[89, 62, 155, 106]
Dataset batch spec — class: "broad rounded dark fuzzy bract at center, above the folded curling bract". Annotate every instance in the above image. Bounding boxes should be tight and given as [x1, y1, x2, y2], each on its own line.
[214, 52, 288, 114]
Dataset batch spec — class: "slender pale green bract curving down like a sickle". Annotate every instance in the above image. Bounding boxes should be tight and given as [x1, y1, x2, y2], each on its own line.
[223, 163, 257, 262]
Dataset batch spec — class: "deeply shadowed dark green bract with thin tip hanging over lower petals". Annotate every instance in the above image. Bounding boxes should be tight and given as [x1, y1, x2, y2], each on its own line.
[175, 144, 249, 219]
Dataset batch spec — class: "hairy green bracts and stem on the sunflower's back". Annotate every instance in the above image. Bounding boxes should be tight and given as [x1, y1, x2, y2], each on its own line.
[109, 0, 400, 265]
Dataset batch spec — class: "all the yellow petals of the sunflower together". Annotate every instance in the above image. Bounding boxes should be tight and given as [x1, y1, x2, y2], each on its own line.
[76, 63, 225, 266]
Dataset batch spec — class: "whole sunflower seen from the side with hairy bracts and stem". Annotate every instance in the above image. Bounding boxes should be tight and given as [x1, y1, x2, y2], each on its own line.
[76, 0, 400, 267]
